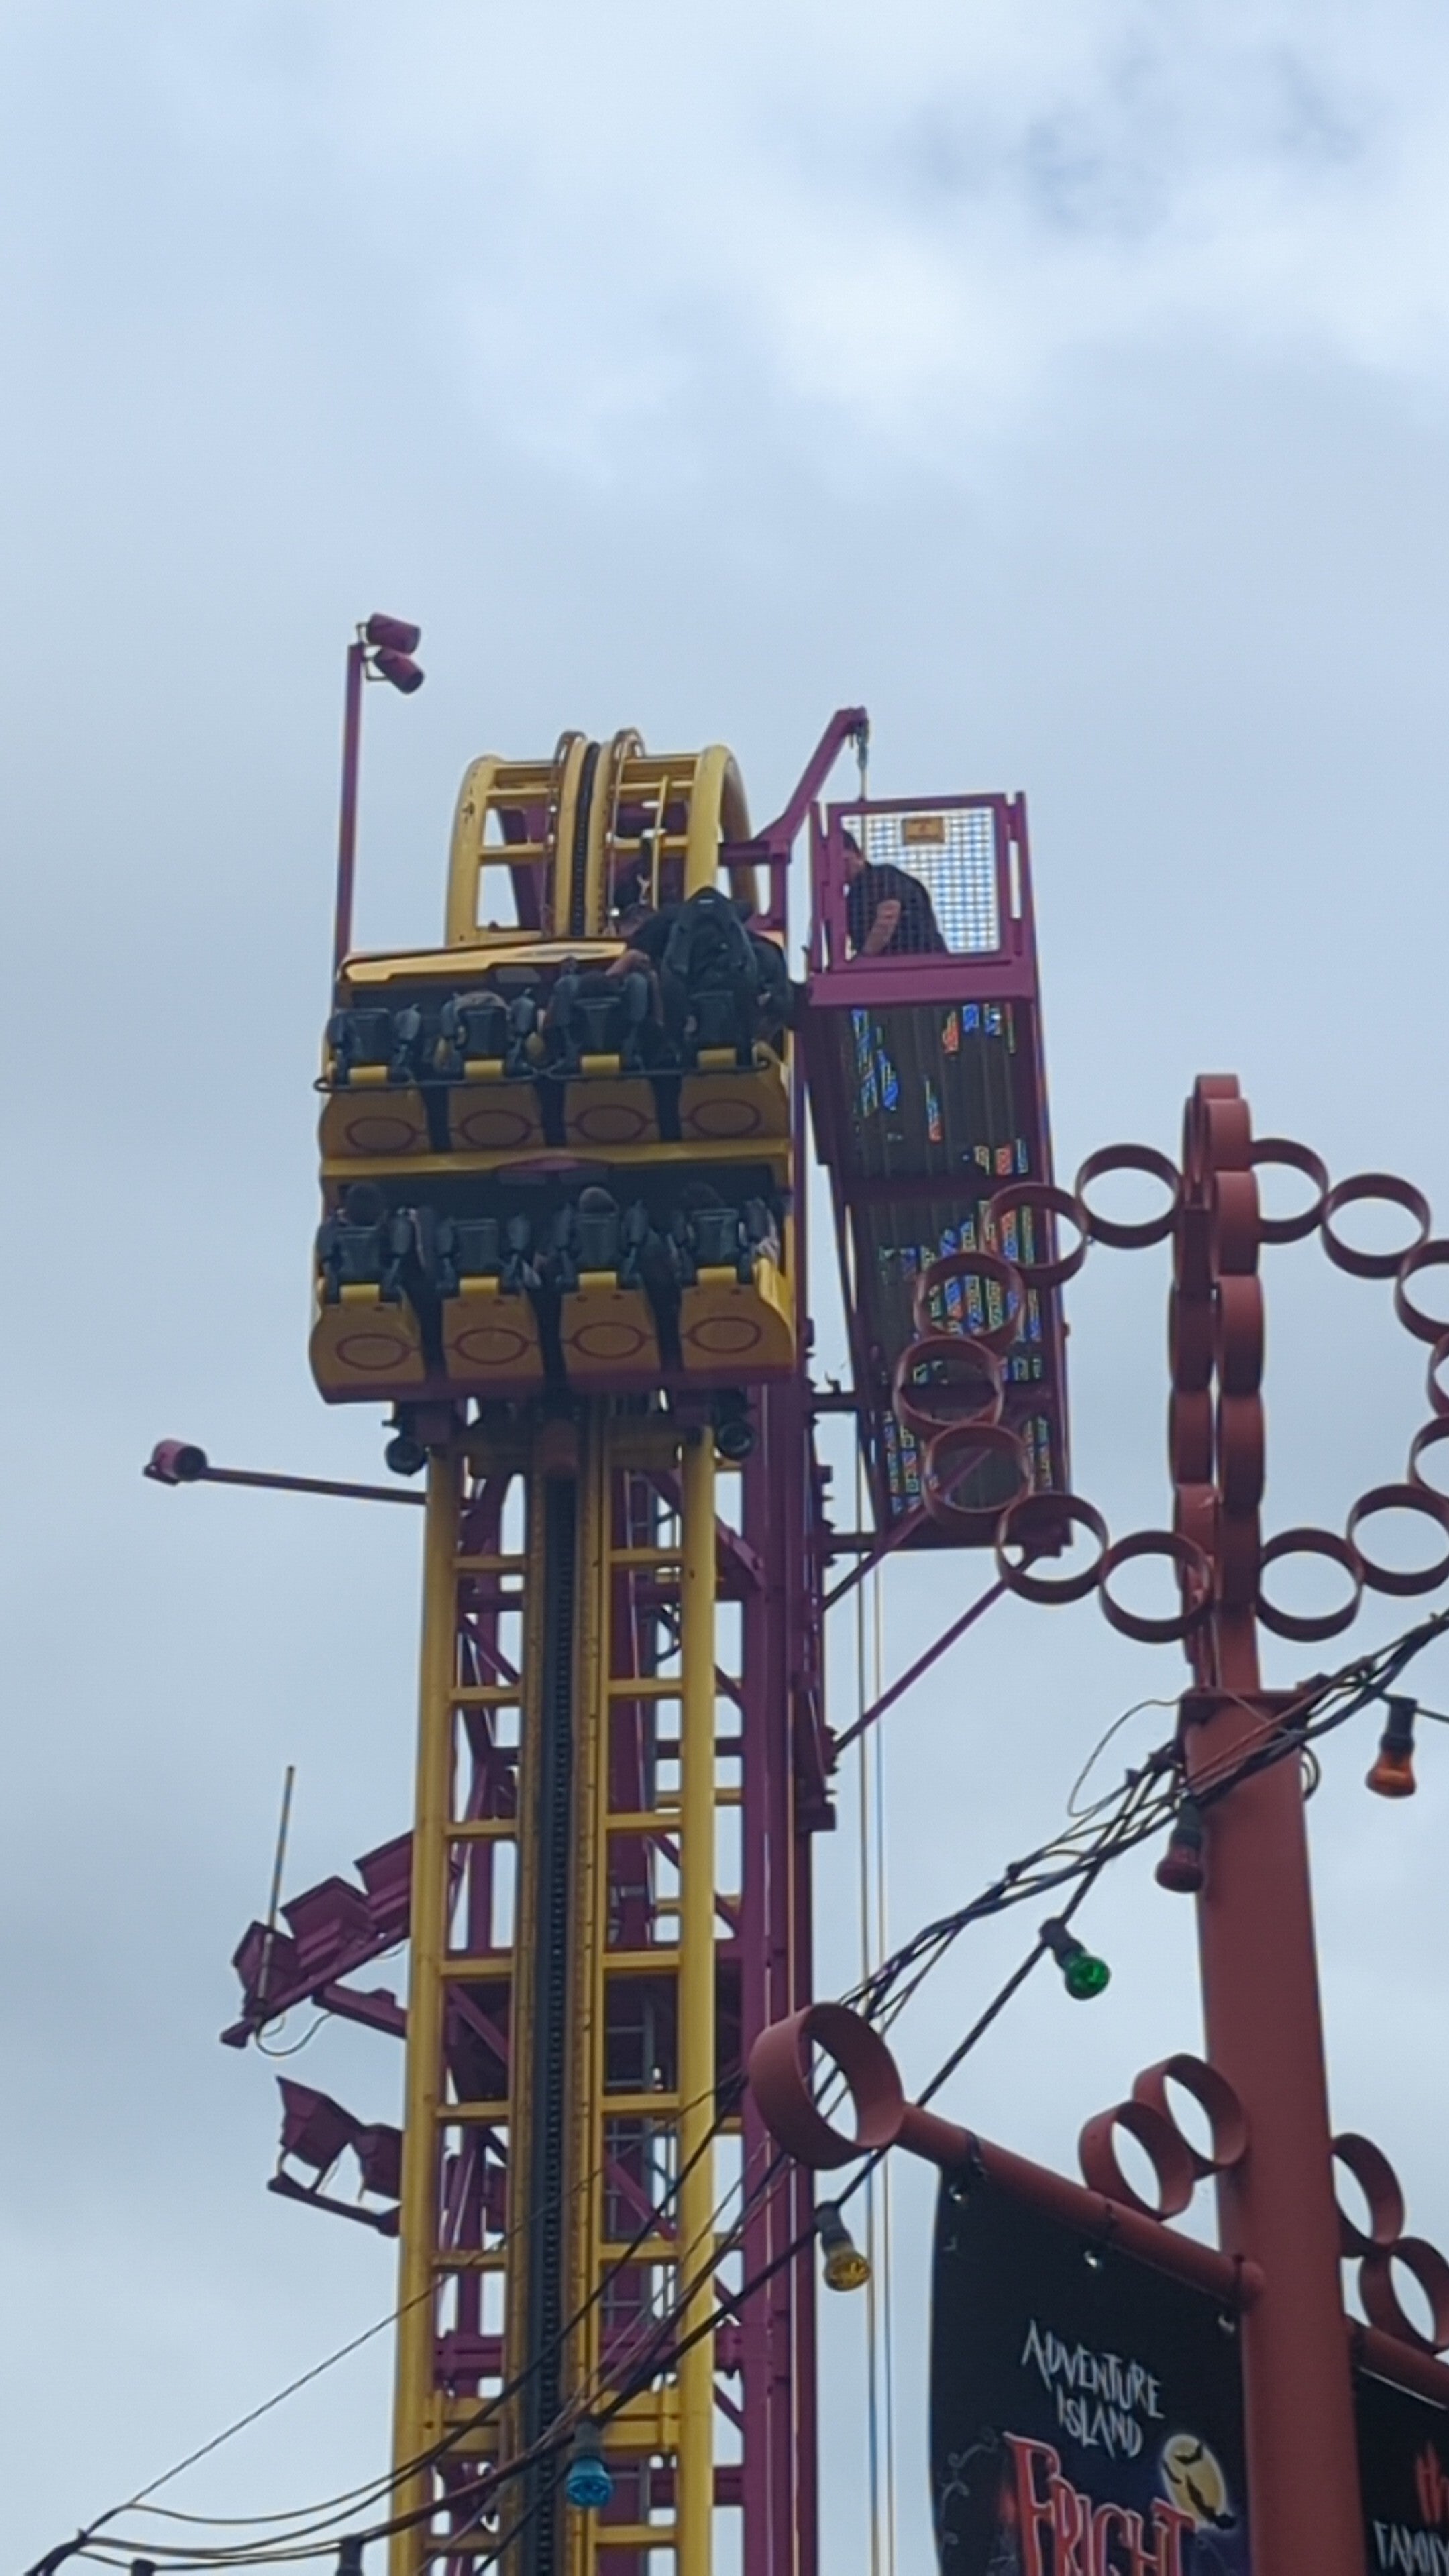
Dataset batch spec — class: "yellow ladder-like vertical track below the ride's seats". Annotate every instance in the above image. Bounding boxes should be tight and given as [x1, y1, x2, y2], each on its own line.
[392, 1401, 737, 2576]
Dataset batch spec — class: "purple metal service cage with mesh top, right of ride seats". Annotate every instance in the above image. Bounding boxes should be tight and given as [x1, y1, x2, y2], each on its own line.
[804, 796, 1067, 1546]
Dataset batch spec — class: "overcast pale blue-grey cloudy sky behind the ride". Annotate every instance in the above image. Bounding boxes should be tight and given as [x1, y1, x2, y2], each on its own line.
[0, 0, 1449, 2576]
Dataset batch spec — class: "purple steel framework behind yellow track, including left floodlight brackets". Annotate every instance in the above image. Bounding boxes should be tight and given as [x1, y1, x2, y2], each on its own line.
[224, 1383, 833, 2576]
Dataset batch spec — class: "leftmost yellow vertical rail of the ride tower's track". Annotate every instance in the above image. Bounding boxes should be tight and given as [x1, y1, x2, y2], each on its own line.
[389, 1450, 459, 2576]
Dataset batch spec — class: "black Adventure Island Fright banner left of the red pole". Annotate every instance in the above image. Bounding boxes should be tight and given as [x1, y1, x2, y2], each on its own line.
[930, 2177, 1248, 2576]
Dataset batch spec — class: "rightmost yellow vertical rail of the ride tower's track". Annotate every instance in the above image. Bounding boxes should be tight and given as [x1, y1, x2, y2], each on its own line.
[676, 1432, 716, 2576]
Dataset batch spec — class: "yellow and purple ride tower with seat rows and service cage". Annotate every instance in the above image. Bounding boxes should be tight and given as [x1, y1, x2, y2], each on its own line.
[227, 708, 1067, 2576]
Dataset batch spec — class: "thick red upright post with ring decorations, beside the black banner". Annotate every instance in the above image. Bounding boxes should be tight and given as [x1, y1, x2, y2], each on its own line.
[1171, 1074, 1364, 2576]
